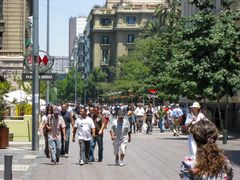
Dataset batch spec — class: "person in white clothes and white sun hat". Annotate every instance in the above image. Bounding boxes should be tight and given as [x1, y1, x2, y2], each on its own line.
[185, 102, 206, 155]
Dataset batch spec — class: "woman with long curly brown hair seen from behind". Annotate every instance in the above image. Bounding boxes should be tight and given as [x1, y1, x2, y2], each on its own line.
[180, 120, 233, 180]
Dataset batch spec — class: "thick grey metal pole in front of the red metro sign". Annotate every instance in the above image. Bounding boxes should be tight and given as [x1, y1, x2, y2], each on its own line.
[32, 0, 39, 151]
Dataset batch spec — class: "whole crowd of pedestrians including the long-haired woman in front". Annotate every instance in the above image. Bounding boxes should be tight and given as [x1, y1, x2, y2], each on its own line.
[40, 102, 233, 179]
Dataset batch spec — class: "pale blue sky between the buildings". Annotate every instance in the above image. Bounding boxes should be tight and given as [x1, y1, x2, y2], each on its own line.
[39, 0, 106, 56]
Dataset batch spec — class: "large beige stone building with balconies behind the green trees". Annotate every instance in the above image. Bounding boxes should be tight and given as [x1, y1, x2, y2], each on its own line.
[88, 0, 164, 78]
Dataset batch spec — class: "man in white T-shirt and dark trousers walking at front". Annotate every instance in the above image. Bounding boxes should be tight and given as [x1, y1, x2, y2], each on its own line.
[72, 108, 95, 165]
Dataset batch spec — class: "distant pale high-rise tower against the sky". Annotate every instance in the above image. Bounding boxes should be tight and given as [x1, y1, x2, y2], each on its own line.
[69, 17, 87, 57]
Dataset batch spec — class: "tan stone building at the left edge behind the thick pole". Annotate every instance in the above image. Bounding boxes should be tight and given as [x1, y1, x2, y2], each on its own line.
[0, 0, 32, 74]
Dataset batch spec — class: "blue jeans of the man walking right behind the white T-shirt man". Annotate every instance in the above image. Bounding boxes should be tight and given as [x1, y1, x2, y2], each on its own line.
[89, 135, 103, 161]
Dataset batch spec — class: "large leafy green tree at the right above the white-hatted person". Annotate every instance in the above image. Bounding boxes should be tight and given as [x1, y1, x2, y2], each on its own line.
[169, 0, 240, 129]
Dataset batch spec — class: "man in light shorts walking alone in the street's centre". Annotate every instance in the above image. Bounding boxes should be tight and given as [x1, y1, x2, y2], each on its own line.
[110, 111, 131, 167]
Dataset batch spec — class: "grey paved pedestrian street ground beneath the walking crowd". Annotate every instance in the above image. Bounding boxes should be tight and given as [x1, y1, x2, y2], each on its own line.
[0, 128, 240, 180]
